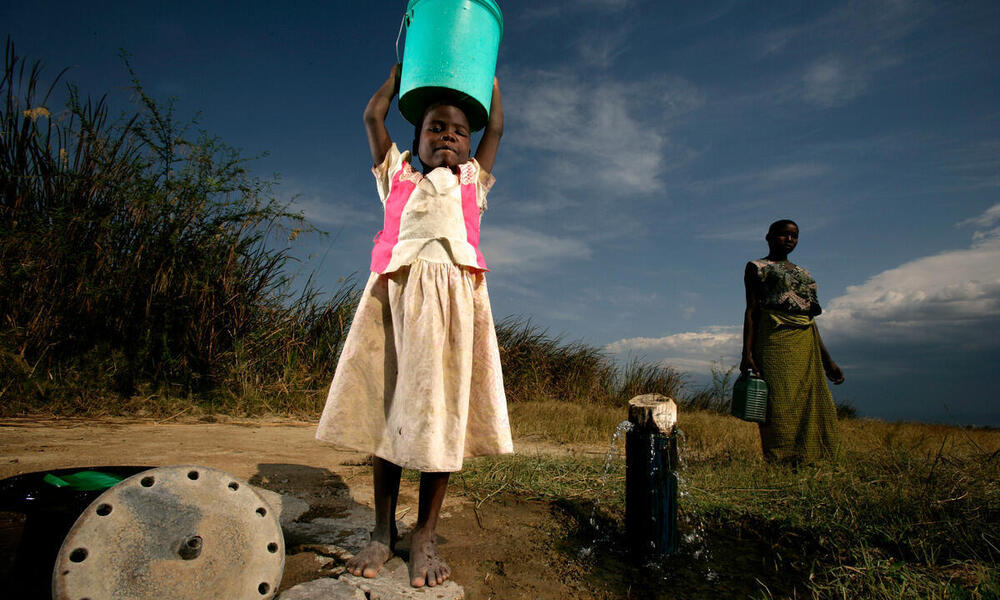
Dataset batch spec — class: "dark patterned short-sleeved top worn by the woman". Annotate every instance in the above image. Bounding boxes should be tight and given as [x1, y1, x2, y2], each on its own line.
[747, 258, 823, 317]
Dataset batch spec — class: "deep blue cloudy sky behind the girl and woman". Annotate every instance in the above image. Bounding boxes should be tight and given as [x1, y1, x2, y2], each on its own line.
[7, 0, 1000, 426]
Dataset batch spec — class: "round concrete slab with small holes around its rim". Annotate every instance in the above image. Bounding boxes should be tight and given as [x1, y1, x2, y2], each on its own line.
[52, 466, 285, 600]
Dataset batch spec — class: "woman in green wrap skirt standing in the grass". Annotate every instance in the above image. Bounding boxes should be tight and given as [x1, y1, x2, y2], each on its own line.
[740, 219, 844, 464]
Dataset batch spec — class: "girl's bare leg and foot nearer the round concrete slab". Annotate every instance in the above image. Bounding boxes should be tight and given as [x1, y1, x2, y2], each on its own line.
[347, 456, 402, 578]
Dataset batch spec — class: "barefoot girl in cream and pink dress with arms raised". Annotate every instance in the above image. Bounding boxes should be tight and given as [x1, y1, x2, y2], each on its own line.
[316, 65, 513, 587]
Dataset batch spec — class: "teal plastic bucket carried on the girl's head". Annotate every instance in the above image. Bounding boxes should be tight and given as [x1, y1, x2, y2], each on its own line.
[399, 0, 503, 131]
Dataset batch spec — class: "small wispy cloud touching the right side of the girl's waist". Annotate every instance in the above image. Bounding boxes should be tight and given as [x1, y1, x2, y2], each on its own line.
[482, 226, 591, 272]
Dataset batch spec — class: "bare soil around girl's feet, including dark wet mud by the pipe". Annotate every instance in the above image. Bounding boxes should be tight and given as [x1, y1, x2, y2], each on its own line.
[0, 419, 794, 600]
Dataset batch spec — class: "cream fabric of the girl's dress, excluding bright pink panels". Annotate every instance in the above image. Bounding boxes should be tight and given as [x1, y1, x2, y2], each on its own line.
[316, 146, 513, 472]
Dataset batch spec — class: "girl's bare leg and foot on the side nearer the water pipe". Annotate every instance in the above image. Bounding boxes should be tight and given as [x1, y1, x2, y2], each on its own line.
[410, 473, 451, 587]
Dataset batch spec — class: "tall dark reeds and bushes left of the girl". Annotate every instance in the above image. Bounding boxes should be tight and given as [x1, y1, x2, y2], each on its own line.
[0, 40, 356, 412]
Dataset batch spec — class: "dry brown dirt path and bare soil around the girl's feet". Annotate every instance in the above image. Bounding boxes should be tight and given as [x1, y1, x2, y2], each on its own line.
[0, 419, 620, 600]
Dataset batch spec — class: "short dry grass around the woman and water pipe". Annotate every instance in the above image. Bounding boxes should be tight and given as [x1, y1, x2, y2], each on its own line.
[454, 402, 1000, 599]
